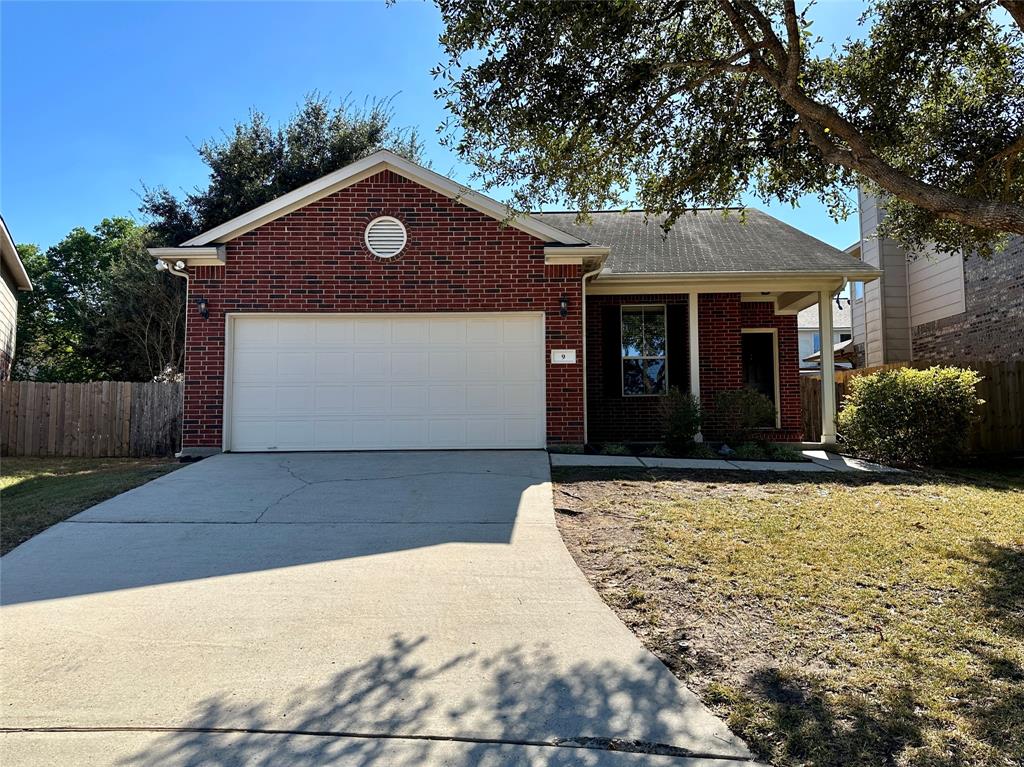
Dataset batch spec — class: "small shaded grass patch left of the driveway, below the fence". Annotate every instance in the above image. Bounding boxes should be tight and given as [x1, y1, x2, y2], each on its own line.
[0, 458, 181, 554]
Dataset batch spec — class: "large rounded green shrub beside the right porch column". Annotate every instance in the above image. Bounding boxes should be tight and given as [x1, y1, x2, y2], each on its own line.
[837, 367, 983, 465]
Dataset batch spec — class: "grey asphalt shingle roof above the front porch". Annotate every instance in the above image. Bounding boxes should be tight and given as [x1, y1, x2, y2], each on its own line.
[532, 208, 874, 274]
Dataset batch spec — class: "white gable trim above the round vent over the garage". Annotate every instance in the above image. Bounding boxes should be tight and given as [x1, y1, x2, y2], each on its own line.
[181, 150, 586, 247]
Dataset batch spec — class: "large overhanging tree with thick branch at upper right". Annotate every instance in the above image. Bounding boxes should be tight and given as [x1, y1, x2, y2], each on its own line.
[435, 0, 1024, 255]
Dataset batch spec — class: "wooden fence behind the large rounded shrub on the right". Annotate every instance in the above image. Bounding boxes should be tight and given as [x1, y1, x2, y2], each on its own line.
[800, 359, 1024, 454]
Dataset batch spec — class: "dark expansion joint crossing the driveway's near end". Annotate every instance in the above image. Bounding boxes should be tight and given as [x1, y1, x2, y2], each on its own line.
[0, 725, 759, 767]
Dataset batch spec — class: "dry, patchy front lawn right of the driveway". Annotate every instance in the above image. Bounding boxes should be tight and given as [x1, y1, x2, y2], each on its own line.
[554, 468, 1024, 767]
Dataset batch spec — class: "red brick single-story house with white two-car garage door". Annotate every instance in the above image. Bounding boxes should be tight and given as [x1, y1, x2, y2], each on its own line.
[151, 152, 878, 456]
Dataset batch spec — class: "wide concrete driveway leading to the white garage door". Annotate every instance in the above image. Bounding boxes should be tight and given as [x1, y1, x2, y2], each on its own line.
[0, 452, 749, 767]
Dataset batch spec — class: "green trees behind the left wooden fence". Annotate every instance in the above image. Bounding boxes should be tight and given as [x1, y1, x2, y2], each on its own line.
[13, 218, 184, 381]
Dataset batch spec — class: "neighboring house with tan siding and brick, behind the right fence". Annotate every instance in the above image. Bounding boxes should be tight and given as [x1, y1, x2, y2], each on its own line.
[852, 193, 1024, 367]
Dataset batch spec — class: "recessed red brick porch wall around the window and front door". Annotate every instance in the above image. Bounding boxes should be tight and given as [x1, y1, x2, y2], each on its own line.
[587, 293, 803, 442]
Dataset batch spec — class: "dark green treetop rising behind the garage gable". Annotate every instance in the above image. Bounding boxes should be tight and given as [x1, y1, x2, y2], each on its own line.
[141, 93, 422, 245]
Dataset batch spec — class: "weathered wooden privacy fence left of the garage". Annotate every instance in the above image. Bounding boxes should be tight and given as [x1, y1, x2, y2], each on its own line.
[0, 381, 182, 458]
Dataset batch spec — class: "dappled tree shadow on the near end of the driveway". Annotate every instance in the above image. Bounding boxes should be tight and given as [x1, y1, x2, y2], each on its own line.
[119, 636, 736, 767]
